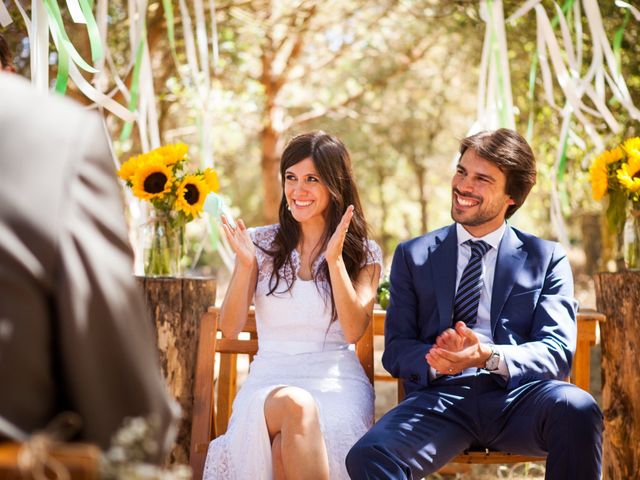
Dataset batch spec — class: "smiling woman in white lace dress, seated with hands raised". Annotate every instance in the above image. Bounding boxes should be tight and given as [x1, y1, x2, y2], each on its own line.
[204, 132, 382, 480]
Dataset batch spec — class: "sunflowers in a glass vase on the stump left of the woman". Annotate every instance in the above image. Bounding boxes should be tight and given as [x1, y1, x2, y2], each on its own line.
[118, 143, 220, 276]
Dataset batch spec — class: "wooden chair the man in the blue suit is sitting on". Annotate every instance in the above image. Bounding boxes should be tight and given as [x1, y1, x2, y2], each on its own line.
[373, 310, 605, 464]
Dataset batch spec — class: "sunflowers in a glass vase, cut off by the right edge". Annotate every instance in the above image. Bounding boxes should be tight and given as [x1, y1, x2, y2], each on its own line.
[589, 137, 640, 269]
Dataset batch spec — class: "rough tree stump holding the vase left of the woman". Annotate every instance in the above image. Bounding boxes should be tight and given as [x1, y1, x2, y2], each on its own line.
[138, 277, 216, 464]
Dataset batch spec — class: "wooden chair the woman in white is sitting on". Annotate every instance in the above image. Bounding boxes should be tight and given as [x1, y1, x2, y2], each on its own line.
[190, 307, 373, 480]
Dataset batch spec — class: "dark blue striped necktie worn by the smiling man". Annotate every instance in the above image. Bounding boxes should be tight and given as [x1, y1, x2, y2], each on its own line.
[453, 240, 491, 327]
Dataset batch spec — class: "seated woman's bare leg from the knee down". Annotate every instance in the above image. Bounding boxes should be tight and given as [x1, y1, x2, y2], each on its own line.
[264, 387, 329, 480]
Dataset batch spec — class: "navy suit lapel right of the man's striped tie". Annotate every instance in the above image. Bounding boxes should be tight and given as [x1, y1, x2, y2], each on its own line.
[491, 225, 527, 332]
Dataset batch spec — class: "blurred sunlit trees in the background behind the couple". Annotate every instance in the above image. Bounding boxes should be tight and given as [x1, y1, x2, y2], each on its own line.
[2, 0, 640, 307]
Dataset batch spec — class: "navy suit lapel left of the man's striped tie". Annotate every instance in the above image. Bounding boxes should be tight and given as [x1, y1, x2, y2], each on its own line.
[430, 223, 458, 331]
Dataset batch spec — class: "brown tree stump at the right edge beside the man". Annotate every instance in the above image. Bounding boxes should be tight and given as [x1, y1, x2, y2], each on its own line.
[595, 271, 640, 480]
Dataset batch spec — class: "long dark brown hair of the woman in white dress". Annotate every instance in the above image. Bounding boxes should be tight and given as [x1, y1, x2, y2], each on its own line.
[265, 131, 369, 320]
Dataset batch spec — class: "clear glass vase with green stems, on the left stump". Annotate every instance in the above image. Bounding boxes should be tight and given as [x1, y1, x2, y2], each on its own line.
[143, 212, 184, 277]
